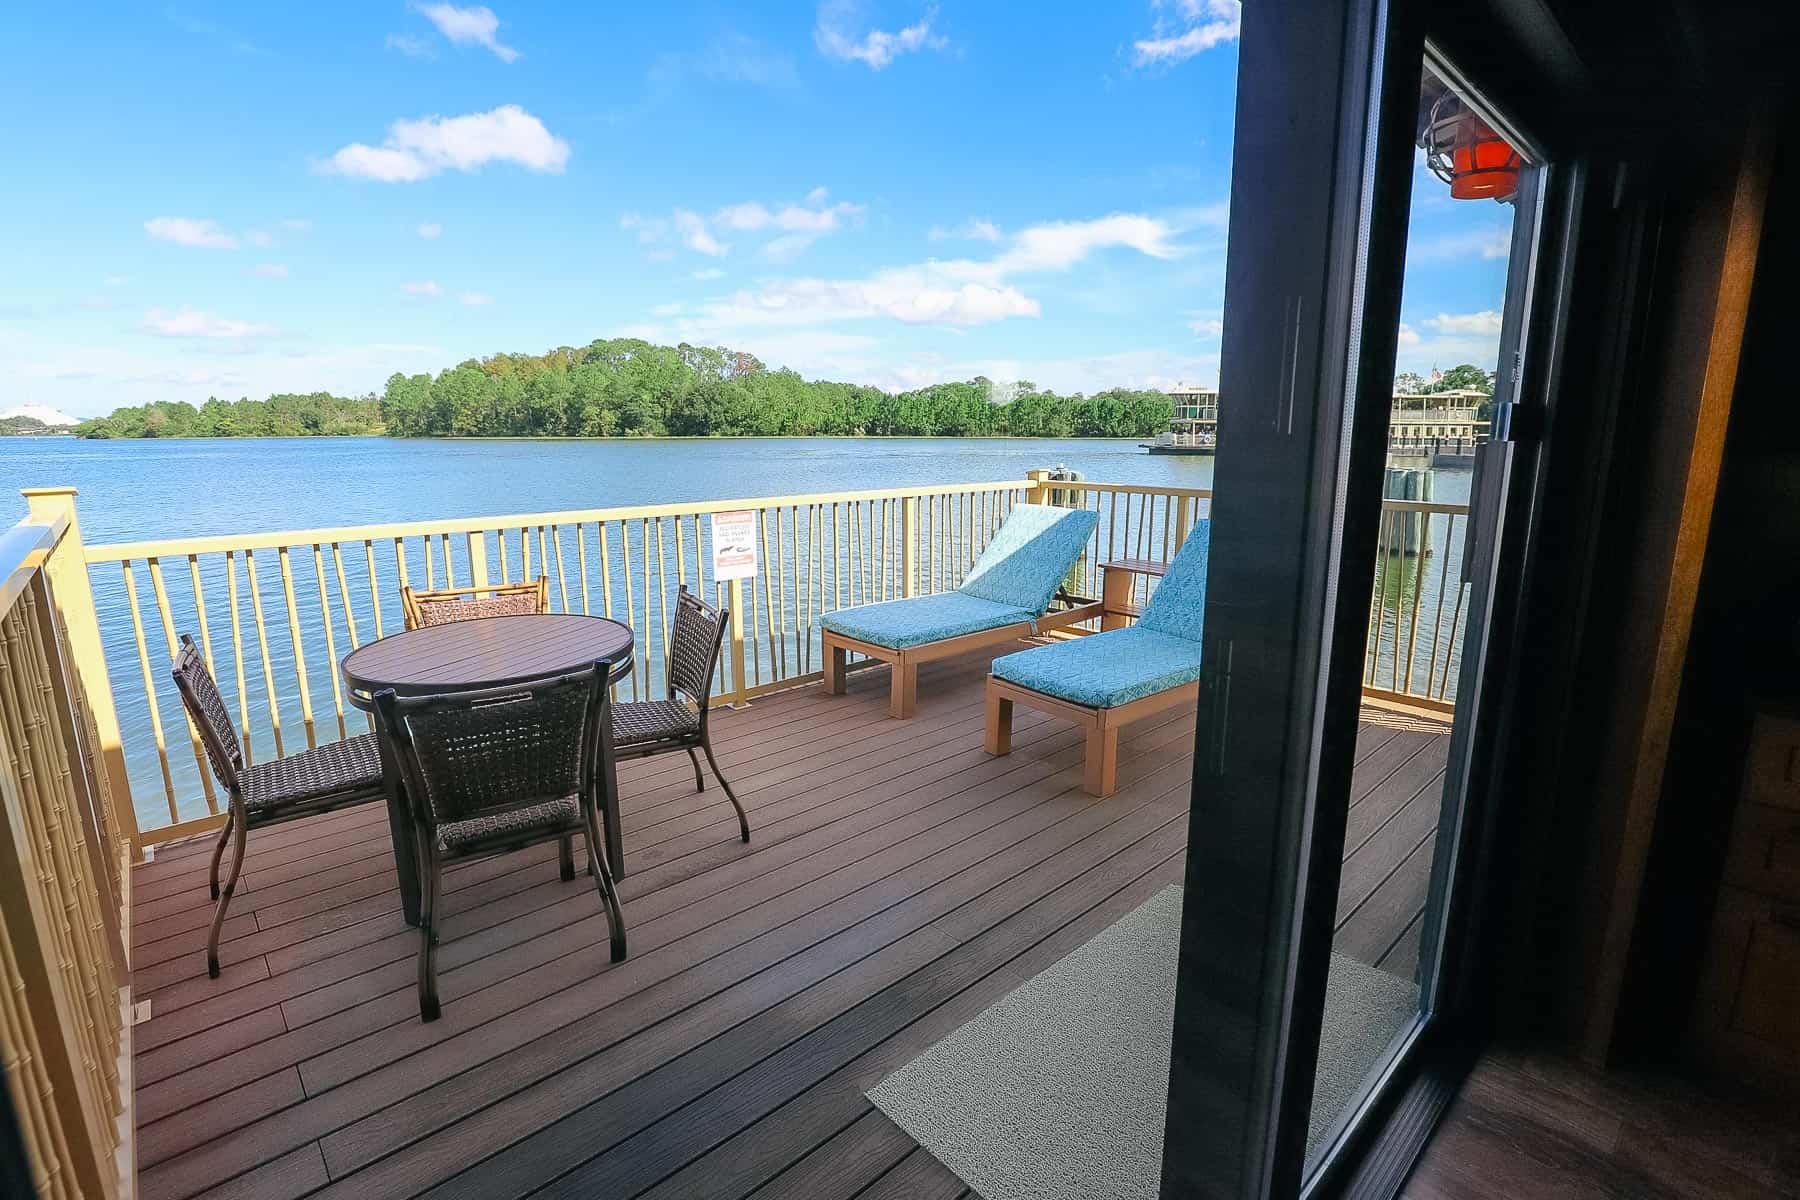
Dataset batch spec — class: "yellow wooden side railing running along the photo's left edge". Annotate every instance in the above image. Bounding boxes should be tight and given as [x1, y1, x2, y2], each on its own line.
[0, 493, 135, 1198]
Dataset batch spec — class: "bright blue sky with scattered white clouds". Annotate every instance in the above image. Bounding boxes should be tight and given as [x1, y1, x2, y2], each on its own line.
[0, 0, 1510, 416]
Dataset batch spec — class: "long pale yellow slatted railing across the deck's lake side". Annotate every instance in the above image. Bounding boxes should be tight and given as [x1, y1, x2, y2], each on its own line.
[17, 471, 1467, 847]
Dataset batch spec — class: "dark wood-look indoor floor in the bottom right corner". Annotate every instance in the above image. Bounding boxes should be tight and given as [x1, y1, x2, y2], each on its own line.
[1402, 1047, 1800, 1200]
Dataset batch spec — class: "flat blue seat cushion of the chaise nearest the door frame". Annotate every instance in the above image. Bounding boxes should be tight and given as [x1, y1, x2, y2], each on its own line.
[994, 624, 1201, 709]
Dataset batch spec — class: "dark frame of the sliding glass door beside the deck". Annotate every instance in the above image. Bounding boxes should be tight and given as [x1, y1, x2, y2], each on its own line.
[1163, 0, 1582, 1198]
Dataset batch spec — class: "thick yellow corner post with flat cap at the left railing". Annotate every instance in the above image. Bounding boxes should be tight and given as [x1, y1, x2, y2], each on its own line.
[20, 488, 142, 862]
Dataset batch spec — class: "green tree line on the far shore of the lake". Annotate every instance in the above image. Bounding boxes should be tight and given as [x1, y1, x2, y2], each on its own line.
[77, 338, 1174, 437]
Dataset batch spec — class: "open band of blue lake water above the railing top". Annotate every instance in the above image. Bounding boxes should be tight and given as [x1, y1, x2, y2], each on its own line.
[0, 437, 1213, 542]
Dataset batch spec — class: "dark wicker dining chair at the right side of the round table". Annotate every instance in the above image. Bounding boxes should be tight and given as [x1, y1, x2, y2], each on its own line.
[612, 585, 751, 842]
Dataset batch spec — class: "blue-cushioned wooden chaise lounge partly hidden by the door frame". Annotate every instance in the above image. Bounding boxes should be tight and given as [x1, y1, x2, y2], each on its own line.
[983, 522, 1211, 795]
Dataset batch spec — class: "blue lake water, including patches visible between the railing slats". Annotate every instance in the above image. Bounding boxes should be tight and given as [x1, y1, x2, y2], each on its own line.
[0, 437, 1469, 829]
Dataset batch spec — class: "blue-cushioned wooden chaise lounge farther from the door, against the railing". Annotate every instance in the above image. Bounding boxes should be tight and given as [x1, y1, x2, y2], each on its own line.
[821, 504, 1100, 720]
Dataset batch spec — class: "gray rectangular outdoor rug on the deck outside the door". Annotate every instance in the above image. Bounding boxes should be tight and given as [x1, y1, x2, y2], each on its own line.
[869, 885, 1418, 1200]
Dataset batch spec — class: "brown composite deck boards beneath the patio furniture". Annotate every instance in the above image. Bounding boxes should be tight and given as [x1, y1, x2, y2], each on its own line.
[133, 655, 1445, 1200]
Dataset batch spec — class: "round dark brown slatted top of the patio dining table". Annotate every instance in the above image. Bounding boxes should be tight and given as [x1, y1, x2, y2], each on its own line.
[344, 613, 632, 711]
